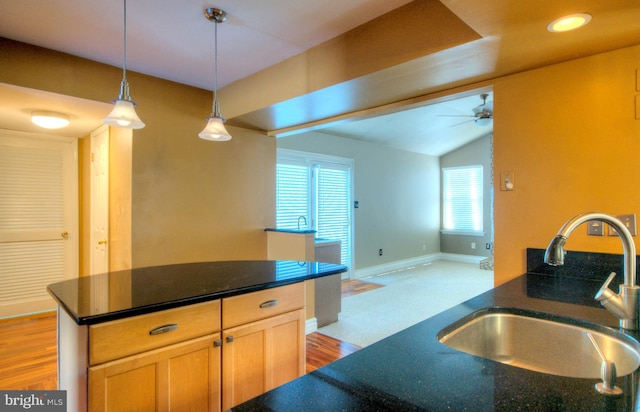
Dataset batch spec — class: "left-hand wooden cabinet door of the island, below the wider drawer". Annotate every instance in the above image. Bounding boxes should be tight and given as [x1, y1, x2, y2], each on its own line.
[89, 333, 220, 412]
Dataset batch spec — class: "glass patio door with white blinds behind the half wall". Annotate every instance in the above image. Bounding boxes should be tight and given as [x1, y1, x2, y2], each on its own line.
[276, 149, 353, 267]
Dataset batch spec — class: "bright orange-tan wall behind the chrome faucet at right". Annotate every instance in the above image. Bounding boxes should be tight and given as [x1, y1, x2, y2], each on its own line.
[494, 42, 640, 284]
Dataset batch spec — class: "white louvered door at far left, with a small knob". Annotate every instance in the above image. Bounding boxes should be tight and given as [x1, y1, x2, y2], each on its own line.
[0, 130, 78, 318]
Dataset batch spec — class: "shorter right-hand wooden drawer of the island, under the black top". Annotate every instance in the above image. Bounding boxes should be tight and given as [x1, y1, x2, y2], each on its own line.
[222, 282, 305, 329]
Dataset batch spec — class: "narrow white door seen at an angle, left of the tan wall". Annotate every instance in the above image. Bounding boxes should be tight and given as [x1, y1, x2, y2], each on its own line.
[89, 126, 109, 275]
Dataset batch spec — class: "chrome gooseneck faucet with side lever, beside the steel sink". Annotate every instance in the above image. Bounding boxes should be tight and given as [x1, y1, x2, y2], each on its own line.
[544, 213, 640, 330]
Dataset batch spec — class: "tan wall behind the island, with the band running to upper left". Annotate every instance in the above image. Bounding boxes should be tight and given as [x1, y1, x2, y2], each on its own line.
[0, 38, 275, 267]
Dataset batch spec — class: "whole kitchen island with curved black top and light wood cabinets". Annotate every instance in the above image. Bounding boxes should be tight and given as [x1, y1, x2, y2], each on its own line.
[47, 260, 347, 411]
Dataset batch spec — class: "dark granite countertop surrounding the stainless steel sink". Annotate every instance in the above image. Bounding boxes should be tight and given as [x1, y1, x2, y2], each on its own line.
[233, 249, 639, 412]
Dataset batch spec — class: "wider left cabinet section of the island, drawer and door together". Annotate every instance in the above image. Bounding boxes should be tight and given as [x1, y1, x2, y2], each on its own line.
[88, 300, 221, 412]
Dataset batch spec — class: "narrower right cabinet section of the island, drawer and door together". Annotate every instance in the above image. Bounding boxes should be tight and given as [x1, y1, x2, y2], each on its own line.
[222, 283, 305, 410]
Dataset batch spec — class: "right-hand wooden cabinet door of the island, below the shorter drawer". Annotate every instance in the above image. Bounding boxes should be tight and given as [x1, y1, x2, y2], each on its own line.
[222, 309, 305, 410]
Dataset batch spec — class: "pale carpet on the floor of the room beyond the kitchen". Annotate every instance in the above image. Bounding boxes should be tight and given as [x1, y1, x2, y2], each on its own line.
[318, 260, 493, 347]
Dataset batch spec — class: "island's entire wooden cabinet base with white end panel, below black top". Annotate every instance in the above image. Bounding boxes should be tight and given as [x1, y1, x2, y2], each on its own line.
[58, 283, 305, 412]
